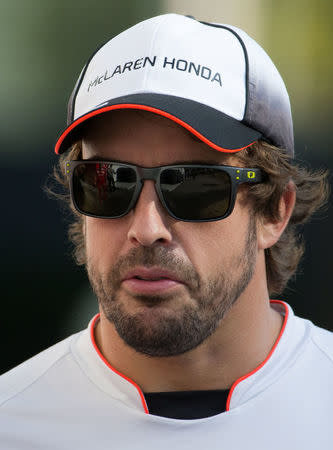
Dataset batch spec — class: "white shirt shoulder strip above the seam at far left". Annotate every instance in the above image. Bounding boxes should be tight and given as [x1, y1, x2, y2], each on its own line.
[0, 332, 81, 407]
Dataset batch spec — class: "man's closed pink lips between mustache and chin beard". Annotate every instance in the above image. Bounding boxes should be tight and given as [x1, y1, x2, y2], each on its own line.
[122, 267, 184, 295]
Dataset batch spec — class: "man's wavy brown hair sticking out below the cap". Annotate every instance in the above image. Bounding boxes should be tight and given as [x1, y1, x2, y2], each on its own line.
[46, 141, 329, 295]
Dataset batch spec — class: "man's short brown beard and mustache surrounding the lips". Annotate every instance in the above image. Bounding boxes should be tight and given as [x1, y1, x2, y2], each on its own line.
[87, 217, 256, 357]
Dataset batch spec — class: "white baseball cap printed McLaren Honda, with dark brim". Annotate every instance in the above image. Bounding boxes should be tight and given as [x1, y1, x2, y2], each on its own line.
[55, 14, 294, 155]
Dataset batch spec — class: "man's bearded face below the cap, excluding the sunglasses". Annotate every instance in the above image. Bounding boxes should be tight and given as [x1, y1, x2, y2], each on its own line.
[83, 111, 257, 356]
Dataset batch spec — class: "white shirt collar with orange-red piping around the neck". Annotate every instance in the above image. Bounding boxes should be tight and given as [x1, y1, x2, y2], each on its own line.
[72, 300, 306, 413]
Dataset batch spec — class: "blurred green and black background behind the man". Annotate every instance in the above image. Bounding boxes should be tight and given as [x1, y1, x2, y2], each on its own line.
[0, 0, 333, 372]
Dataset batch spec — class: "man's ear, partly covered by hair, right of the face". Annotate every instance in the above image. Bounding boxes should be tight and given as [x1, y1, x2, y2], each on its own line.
[258, 181, 296, 250]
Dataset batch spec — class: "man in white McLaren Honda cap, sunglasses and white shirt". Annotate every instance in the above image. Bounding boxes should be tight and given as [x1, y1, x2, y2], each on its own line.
[0, 14, 333, 450]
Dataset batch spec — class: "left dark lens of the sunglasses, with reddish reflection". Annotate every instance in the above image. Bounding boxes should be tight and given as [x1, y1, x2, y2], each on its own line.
[73, 163, 137, 217]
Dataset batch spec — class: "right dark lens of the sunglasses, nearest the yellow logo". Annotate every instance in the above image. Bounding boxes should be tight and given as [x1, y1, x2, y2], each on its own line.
[160, 167, 231, 220]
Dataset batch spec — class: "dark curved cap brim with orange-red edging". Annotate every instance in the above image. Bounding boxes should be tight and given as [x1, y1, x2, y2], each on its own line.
[55, 93, 262, 154]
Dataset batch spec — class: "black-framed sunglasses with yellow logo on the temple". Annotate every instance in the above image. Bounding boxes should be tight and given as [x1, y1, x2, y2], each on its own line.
[66, 160, 264, 222]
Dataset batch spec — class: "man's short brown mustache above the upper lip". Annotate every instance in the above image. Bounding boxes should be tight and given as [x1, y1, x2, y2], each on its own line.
[109, 246, 201, 291]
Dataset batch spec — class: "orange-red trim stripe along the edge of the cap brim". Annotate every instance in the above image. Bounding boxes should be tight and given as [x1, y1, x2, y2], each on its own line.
[55, 103, 255, 154]
